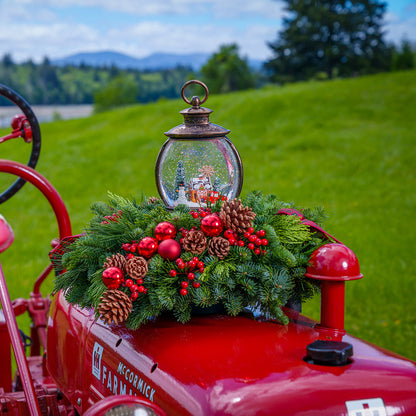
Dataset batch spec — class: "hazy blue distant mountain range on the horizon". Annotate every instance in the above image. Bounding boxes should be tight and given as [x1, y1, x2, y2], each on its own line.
[52, 51, 262, 71]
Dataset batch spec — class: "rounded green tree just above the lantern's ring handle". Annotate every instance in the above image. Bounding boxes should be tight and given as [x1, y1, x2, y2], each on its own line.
[201, 44, 255, 93]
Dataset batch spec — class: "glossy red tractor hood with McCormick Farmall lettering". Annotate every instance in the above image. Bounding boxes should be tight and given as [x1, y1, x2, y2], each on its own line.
[48, 294, 416, 416]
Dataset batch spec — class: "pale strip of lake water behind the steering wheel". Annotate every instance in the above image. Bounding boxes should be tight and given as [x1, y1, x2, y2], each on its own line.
[0, 104, 93, 127]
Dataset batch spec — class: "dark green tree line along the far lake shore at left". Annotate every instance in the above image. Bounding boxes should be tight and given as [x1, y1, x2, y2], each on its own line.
[0, 54, 191, 109]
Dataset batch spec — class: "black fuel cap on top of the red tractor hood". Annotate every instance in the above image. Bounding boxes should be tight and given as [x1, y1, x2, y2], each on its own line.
[305, 340, 353, 366]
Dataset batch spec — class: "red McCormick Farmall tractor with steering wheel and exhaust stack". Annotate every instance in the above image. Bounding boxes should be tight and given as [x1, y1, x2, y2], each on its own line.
[0, 82, 416, 416]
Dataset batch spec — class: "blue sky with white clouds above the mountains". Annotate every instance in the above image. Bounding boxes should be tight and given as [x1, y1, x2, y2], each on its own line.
[0, 0, 416, 62]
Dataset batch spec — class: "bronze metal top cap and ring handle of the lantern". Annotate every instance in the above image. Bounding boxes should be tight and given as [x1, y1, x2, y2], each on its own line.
[165, 79, 230, 139]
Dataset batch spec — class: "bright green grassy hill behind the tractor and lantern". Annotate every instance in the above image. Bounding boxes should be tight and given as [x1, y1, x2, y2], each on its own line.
[0, 71, 416, 359]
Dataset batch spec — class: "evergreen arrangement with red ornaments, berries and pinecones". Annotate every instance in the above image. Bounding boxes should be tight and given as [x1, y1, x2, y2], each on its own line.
[51, 192, 325, 329]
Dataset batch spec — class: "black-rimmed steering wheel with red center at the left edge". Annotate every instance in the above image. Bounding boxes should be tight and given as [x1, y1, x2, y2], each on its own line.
[0, 84, 41, 204]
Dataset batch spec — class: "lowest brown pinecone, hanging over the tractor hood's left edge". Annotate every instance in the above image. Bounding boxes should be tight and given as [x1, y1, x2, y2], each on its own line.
[97, 289, 133, 325]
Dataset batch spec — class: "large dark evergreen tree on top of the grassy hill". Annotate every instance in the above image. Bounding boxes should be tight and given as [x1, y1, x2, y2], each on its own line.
[266, 0, 391, 81]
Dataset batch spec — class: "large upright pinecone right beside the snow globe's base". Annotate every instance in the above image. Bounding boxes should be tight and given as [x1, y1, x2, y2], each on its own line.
[219, 199, 256, 234]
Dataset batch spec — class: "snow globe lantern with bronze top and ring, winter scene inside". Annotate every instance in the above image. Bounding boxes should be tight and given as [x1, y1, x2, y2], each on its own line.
[155, 80, 243, 209]
